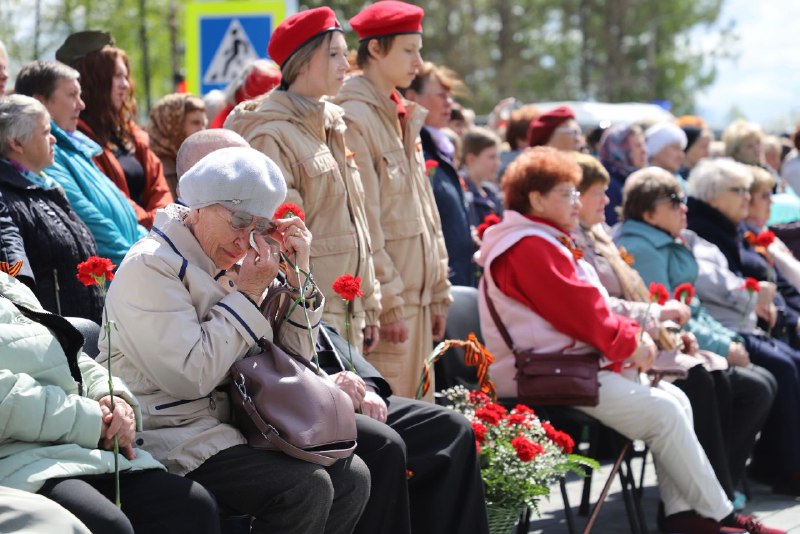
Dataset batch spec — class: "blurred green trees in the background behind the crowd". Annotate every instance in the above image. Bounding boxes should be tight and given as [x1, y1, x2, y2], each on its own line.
[0, 0, 735, 118]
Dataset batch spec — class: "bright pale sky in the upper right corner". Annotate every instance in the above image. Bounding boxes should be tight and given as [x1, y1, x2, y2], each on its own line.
[694, 0, 800, 131]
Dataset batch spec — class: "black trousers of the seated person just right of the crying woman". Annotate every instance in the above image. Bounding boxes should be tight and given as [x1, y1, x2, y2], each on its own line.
[355, 396, 489, 534]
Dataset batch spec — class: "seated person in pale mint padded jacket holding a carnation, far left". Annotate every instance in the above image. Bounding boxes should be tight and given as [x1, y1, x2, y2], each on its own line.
[0, 272, 219, 534]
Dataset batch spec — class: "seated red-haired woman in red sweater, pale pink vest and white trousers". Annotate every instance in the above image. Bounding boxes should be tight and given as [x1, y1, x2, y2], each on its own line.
[478, 147, 779, 534]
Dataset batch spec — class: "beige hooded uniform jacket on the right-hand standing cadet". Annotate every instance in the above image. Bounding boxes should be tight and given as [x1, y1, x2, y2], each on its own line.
[334, 76, 451, 323]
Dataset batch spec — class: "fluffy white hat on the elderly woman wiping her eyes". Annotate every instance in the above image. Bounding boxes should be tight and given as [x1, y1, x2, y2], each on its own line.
[178, 147, 286, 219]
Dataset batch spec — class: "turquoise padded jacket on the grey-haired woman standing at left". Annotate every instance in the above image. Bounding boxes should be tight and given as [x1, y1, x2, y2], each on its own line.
[45, 125, 147, 265]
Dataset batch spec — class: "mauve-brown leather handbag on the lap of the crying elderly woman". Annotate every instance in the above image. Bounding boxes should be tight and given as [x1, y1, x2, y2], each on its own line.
[230, 288, 356, 466]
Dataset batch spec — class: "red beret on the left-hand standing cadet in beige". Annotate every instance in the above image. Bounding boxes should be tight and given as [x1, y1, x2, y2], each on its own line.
[267, 7, 342, 67]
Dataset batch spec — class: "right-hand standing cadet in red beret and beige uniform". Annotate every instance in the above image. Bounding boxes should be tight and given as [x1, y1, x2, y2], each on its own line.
[334, 0, 451, 408]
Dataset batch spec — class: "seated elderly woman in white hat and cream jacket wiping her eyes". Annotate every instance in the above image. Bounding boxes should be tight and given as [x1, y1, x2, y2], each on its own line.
[101, 147, 369, 533]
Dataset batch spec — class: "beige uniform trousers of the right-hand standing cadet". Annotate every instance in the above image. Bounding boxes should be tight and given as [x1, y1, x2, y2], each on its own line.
[367, 306, 435, 402]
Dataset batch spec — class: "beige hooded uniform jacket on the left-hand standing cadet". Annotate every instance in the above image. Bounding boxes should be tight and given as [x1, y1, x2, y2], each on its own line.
[225, 91, 381, 328]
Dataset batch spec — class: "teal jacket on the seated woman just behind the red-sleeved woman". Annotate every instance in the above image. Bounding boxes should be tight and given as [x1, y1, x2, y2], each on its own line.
[614, 220, 740, 356]
